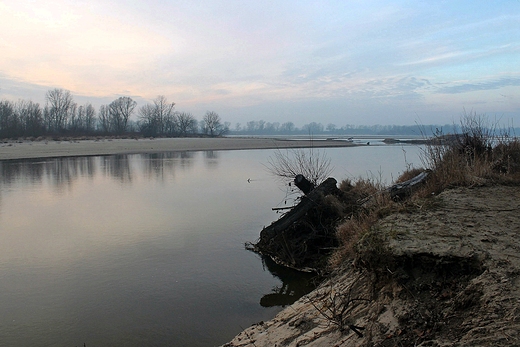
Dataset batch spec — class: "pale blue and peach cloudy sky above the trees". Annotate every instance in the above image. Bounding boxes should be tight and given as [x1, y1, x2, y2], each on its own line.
[0, 0, 520, 127]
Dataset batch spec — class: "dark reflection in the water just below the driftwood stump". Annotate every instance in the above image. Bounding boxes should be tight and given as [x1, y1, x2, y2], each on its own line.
[260, 256, 318, 307]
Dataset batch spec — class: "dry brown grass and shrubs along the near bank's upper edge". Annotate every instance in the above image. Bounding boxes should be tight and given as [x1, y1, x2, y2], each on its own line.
[329, 114, 520, 268]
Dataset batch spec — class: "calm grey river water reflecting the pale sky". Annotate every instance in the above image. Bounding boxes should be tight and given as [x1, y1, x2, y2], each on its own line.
[0, 146, 420, 347]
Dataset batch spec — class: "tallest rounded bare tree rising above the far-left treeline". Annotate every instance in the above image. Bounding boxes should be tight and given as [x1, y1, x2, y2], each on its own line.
[44, 88, 75, 132]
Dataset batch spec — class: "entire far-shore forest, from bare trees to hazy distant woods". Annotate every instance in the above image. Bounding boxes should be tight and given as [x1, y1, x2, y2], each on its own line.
[0, 89, 520, 139]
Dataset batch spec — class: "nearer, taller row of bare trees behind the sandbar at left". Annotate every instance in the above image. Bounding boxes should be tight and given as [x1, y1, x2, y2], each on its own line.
[0, 89, 229, 138]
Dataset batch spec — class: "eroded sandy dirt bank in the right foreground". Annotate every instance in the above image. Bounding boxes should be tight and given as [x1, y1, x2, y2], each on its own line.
[224, 186, 520, 347]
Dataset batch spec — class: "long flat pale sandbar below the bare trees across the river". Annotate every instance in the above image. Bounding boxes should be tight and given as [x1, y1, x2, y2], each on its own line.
[0, 137, 354, 160]
